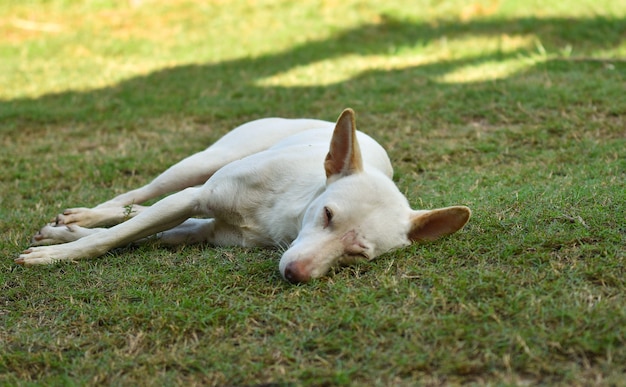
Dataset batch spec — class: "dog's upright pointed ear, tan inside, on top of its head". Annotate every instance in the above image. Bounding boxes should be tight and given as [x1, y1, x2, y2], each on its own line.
[324, 109, 363, 178]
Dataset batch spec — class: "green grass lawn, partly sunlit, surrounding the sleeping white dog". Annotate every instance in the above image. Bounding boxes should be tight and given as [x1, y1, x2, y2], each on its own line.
[0, 0, 626, 385]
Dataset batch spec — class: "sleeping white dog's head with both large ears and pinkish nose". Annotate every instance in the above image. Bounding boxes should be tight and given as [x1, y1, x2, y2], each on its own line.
[280, 109, 471, 283]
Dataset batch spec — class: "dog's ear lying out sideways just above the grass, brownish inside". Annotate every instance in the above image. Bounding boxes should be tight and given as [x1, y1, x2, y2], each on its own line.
[409, 206, 472, 242]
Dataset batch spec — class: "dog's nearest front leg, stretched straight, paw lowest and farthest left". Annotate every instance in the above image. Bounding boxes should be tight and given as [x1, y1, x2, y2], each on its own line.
[15, 188, 205, 265]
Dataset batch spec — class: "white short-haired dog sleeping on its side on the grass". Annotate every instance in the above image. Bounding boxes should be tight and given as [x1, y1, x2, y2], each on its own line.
[15, 109, 471, 283]
